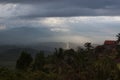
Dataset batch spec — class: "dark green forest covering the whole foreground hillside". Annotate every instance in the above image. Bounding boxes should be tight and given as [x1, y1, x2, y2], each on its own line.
[0, 33, 120, 80]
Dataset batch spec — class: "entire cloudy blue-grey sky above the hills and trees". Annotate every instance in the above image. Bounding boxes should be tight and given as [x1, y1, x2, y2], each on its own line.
[0, 0, 120, 44]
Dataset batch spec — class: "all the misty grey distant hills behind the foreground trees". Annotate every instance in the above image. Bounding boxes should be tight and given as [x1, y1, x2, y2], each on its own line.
[0, 42, 78, 66]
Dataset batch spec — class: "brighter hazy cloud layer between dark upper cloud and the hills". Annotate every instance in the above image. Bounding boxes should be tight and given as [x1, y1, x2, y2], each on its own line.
[0, 16, 120, 44]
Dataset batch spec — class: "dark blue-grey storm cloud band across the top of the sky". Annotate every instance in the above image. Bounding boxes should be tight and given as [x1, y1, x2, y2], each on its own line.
[0, 0, 120, 18]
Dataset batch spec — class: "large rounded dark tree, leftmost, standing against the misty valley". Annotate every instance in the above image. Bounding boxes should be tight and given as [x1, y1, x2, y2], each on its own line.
[16, 51, 33, 70]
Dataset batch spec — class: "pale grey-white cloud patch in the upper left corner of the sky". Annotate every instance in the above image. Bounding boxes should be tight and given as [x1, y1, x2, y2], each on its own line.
[0, 3, 32, 18]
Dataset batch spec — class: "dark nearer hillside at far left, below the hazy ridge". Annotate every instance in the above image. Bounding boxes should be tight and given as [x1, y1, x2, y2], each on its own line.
[0, 45, 38, 68]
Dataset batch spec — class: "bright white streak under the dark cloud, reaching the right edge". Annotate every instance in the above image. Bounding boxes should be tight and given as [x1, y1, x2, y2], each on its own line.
[67, 16, 120, 23]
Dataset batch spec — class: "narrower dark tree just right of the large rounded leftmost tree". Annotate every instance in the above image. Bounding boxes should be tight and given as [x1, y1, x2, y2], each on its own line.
[33, 51, 45, 70]
